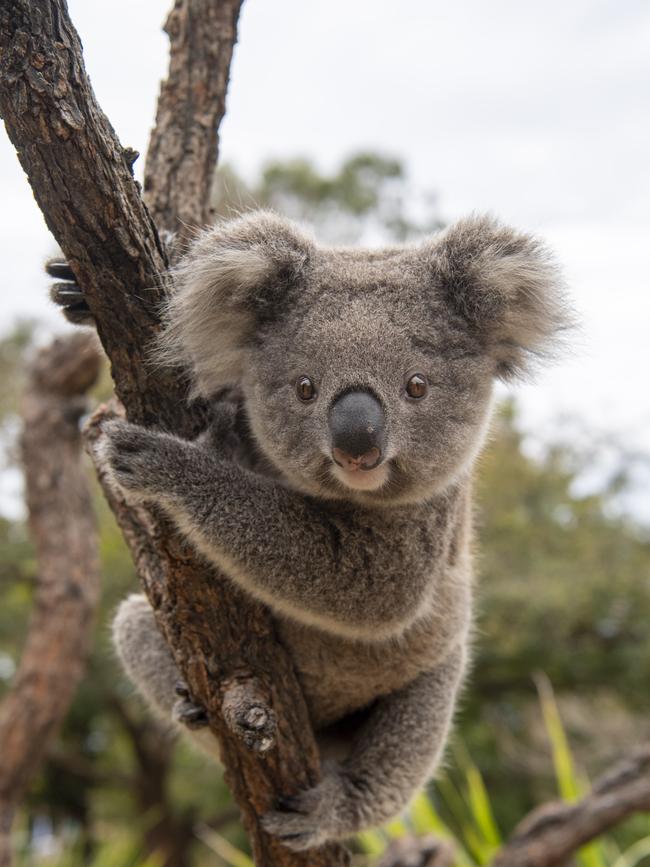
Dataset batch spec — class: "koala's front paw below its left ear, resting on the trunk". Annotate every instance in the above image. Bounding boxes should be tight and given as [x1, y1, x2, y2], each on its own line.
[97, 420, 192, 502]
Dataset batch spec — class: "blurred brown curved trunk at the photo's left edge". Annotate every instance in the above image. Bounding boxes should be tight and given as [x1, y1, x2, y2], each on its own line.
[0, 334, 100, 867]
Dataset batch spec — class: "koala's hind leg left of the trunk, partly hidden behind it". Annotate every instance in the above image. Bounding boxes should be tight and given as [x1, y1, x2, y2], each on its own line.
[113, 594, 218, 757]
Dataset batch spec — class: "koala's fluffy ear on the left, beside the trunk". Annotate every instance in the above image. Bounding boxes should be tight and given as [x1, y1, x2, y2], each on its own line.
[156, 211, 314, 397]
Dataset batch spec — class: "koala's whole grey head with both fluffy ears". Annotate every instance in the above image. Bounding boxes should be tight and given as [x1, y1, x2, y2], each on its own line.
[159, 212, 567, 504]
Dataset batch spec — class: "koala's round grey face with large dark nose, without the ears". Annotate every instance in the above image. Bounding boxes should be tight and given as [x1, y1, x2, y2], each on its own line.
[244, 253, 494, 503]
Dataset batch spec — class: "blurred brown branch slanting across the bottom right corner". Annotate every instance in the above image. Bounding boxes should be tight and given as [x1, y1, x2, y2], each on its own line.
[492, 746, 650, 867]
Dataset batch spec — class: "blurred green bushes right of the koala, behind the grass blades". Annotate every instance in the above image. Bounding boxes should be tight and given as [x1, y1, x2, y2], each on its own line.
[462, 404, 650, 827]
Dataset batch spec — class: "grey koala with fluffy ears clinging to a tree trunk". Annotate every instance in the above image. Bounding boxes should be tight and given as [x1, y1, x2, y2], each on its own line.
[49, 212, 569, 850]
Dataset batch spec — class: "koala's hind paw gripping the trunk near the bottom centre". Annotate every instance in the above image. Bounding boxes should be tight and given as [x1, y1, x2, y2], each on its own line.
[262, 762, 359, 852]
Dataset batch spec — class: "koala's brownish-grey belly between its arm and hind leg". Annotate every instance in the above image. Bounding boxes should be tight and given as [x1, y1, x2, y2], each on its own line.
[278, 619, 450, 729]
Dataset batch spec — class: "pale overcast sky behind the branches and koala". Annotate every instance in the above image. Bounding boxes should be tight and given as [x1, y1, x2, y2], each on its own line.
[0, 0, 650, 515]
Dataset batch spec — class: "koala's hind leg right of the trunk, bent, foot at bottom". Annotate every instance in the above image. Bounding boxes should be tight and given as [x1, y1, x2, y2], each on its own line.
[263, 648, 464, 850]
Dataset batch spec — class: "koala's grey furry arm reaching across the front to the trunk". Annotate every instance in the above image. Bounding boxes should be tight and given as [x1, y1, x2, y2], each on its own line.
[104, 422, 430, 638]
